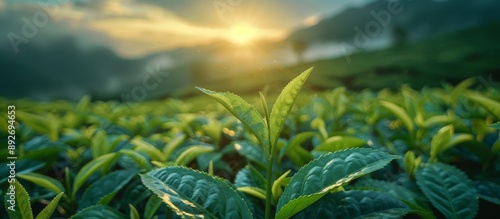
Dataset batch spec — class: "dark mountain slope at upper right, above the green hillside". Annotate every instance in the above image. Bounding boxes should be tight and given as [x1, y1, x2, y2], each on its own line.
[285, 0, 500, 43]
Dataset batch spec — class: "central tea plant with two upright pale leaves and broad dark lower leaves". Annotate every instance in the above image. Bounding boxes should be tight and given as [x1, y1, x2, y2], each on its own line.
[141, 68, 407, 218]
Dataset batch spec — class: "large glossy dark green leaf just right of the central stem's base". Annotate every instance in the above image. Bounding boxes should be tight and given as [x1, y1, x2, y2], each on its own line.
[276, 148, 399, 218]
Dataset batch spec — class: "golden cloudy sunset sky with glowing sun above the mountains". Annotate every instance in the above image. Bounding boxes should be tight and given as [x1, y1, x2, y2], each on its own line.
[0, 0, 372, 58]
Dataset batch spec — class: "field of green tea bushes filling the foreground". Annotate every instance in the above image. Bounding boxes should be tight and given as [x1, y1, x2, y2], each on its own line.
[0, 69, 500, 219]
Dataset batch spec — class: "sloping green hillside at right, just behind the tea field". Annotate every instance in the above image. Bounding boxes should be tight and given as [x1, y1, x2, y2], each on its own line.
[190, 23, 500, 93]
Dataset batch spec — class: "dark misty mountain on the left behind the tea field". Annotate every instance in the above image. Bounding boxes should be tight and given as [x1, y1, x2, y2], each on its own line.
[0, 34, 184, 101]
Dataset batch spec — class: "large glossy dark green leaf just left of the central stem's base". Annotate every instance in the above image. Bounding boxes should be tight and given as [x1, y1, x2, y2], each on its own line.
[141, 167, 252, 219]
